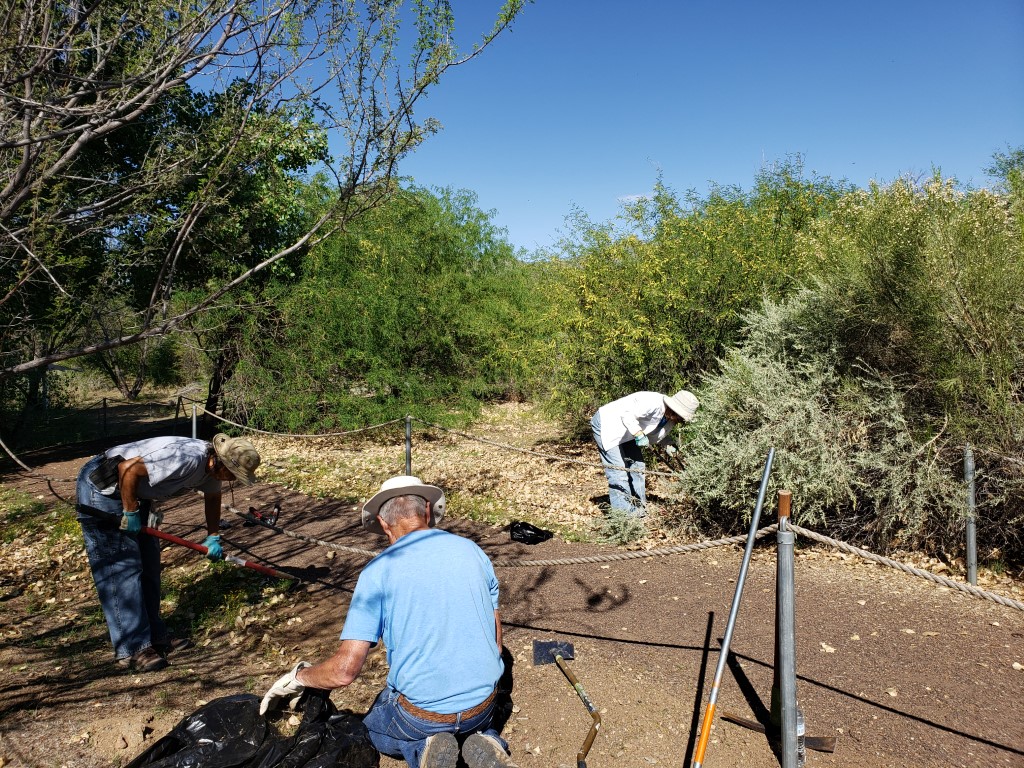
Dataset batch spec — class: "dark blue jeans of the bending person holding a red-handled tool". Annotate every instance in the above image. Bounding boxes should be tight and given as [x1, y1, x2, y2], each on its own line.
[76, 457, 169, 659]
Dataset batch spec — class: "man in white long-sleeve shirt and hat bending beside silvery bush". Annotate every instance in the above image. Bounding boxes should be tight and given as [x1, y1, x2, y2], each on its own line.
[590, 389, 700, 517]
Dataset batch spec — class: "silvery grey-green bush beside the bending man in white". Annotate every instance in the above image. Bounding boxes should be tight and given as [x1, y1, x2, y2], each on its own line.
[682, 291, 961, 547]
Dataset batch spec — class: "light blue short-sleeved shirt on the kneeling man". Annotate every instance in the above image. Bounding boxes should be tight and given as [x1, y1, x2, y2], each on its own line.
[341, 528, 503, 715]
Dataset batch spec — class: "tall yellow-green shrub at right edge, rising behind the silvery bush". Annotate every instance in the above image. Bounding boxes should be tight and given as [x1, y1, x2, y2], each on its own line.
[803, 178, 1024, 451]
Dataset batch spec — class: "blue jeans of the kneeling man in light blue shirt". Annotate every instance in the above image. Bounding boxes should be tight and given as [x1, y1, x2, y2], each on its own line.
[362, 686, 508, 768]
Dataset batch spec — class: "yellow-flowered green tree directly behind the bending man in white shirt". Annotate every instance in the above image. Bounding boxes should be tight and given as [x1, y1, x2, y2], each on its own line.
[550, 160, 842, 434]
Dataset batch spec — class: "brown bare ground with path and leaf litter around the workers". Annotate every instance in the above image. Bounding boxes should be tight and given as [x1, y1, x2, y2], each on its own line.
[0, 406, 1024, 768]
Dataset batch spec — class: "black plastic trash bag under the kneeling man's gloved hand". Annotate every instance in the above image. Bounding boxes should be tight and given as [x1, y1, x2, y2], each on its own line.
[126, 688, 380, 768]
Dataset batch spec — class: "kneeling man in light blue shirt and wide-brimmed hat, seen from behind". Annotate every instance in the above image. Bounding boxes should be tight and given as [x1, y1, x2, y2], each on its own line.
[260, 475, 514, 768]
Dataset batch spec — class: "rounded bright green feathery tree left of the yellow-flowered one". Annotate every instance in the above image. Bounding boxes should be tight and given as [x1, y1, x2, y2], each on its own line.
[229, 183, 552, 432]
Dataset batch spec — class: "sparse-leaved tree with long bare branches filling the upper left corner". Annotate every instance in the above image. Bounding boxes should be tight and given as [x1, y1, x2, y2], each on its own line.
[0, 0, 524, 399]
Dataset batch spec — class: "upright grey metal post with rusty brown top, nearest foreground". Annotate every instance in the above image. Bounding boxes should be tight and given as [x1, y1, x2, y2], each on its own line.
[771, 490, 802, 768]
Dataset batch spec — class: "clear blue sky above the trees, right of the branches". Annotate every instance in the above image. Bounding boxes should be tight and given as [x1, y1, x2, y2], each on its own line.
[399, 0, 1024, 251]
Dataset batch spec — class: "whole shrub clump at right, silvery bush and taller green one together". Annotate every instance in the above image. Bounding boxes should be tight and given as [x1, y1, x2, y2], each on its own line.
[686, 166, 1024, 561]
